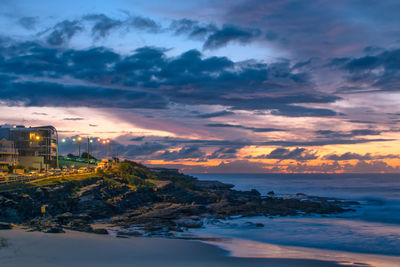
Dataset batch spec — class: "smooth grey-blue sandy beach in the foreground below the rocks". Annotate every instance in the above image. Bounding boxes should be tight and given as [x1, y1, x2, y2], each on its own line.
[0, 229, 346, 267]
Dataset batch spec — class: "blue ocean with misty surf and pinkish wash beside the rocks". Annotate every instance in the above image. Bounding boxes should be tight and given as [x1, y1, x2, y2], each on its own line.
[190, 174, 400, 266]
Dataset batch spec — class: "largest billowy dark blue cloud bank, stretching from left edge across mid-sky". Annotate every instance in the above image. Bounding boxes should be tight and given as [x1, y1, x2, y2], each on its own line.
[0, 42, 340, 117]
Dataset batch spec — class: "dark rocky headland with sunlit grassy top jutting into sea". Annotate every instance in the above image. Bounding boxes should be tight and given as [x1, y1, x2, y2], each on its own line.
[0, 162, 357, 237]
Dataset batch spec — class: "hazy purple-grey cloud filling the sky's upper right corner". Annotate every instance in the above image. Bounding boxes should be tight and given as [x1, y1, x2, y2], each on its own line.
[225, 0, 400, 58]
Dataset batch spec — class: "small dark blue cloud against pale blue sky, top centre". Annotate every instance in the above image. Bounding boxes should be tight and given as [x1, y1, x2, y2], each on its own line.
[203, 25, 261, 50]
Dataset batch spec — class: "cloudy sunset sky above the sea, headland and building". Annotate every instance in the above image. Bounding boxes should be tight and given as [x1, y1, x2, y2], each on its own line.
[0, 0, 400, 173]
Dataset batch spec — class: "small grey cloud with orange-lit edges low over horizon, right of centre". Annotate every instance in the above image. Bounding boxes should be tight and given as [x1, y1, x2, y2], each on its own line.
[255, 148, 318, 161]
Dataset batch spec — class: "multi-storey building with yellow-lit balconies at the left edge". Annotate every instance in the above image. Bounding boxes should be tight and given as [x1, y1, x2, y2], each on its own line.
[0, 125, 58, 169]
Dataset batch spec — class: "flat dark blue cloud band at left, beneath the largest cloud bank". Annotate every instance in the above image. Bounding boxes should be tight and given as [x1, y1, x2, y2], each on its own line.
[0, 82, 167, 109]
